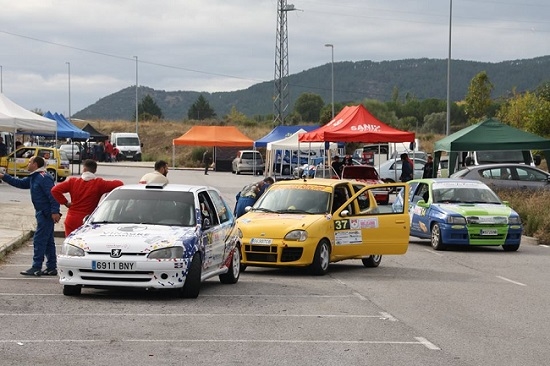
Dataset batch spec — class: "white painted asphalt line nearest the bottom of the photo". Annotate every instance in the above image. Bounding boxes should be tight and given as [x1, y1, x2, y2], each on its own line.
[0, 337, 440, 350]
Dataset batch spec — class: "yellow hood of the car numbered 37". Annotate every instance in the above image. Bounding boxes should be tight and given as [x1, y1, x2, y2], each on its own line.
[237, 212, 329, 238]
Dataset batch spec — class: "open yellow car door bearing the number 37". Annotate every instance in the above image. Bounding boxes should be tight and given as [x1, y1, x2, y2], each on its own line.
[332, 183, 409, 260]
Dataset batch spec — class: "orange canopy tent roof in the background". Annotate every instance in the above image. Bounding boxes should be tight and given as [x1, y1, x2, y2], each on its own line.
[172, 126, 254, 147]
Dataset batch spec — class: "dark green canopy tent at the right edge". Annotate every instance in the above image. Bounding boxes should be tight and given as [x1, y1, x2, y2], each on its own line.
[434, 118, 550, 175]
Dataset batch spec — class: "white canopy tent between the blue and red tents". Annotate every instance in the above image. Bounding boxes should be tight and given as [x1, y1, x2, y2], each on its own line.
[265, 129, 338, 176]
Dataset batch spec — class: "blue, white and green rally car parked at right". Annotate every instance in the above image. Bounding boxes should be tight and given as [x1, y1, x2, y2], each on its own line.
[393, 178, 523, 251]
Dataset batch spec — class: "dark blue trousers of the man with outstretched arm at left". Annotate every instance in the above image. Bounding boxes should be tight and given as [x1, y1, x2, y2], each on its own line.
[32, 211, 57, 269]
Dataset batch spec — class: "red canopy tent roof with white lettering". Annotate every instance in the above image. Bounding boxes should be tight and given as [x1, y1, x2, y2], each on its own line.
[299, 104, 415, 143]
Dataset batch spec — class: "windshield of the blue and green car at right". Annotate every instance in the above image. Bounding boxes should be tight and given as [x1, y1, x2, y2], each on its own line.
[432, 184, 502, 204]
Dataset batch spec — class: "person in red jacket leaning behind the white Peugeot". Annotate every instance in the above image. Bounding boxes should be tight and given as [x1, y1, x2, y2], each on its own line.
[51, 159, 124, 237]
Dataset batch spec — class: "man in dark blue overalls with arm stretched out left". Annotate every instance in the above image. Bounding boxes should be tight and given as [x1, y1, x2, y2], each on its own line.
[0, 156, 61, 276]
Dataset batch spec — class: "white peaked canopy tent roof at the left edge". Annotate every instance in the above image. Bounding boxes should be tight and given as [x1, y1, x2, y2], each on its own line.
[0, 93, 57, 135]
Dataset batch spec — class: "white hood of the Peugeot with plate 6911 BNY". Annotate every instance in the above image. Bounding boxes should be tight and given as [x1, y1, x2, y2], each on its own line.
[65, 224, 197, 253]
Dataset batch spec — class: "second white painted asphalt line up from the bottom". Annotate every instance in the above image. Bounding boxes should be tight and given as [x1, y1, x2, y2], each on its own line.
[0, 313, 385, 320]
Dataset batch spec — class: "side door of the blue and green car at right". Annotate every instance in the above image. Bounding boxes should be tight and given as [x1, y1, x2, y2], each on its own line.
[409, 182, 433, 238]
